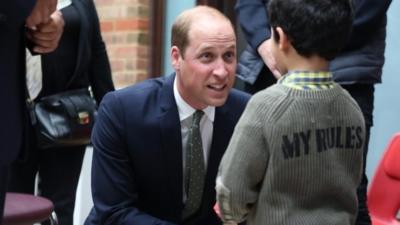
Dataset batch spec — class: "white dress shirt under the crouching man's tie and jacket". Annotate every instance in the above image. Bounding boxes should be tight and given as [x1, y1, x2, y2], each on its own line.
[174, 77, 215, 202]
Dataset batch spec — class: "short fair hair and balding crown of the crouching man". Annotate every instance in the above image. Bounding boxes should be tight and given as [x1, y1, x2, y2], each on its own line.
[171, 6, 233, 57]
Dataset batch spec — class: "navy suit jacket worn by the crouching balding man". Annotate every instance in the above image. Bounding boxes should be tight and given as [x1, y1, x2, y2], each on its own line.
[85, 75, 249, 225]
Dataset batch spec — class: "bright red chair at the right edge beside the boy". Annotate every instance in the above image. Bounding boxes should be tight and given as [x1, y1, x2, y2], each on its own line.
[368, 133, 400, 225]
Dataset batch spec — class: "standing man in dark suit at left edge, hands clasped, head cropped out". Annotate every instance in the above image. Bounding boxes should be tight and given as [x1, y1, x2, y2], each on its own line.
[0, 0, 58, 221]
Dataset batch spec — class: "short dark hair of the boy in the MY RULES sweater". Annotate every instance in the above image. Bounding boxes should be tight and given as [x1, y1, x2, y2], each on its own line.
[268, 0, 354, 60]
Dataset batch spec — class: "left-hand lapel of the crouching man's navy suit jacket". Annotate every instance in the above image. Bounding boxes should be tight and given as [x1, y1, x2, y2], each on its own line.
[159, 76, 183, 215]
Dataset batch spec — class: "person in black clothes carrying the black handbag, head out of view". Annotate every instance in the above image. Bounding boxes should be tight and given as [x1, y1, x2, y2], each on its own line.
[8, 0, 114, 225]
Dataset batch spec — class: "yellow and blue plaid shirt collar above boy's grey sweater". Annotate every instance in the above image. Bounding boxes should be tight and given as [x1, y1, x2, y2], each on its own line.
[278, 71, 334, 90]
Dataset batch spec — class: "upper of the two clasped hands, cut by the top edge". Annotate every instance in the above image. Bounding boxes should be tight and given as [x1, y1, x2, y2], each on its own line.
[26, 0, 57, 30]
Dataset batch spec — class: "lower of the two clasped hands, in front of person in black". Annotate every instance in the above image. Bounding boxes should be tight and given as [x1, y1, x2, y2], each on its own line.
[27, 11, 64, 54]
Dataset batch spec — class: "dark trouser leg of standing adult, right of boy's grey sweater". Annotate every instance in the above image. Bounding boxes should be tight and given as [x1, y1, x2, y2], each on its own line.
[342, 84, 374, 225]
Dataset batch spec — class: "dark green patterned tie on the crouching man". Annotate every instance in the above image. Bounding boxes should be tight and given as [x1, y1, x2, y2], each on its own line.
[182, 110, 206, 219]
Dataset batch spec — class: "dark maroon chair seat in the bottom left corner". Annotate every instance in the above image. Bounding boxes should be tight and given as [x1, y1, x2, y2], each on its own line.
[2, 192, 58, 225]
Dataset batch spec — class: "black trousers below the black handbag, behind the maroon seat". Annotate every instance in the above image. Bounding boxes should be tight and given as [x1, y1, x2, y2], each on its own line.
[8, 142, 86, 225]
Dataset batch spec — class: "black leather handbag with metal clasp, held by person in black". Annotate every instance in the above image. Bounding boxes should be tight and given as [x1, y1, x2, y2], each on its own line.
[30, 89, 97, 149]
